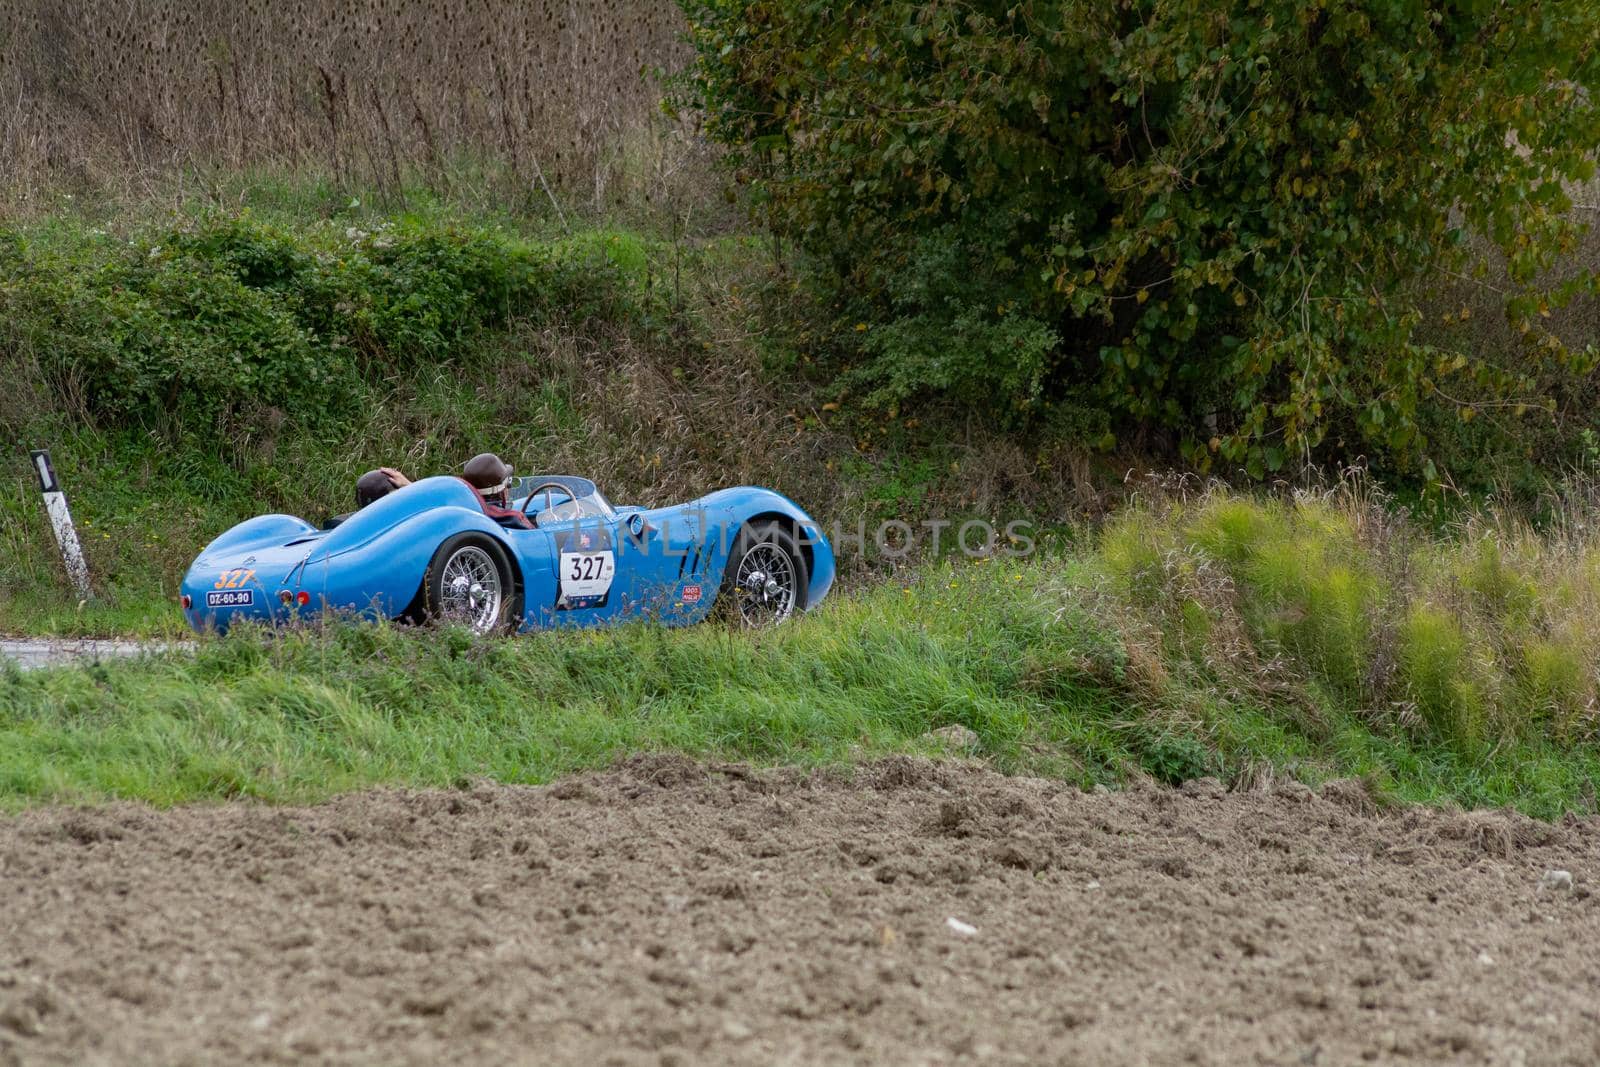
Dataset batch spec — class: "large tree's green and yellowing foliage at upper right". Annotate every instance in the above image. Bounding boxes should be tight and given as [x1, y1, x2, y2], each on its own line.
[682, 0, 1600, 475]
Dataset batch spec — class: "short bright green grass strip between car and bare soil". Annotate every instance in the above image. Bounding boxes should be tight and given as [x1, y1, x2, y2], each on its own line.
[9, 558, 1600, 817]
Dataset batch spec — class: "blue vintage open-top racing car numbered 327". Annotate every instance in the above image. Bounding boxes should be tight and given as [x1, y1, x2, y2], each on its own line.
[181, 475, 834, 633]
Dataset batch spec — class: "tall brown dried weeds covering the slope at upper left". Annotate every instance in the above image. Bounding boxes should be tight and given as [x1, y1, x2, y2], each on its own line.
[0, 0, 699, 213]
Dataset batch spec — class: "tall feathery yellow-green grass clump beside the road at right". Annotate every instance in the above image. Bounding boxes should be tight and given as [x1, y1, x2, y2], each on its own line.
[1099, 474, 1600, 750]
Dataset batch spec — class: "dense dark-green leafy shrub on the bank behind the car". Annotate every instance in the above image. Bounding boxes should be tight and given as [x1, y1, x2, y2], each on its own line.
[0, 216, 626, 437]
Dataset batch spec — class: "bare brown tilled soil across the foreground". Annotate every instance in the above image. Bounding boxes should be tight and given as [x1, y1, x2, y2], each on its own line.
[0, 758, 1600, 1067]
